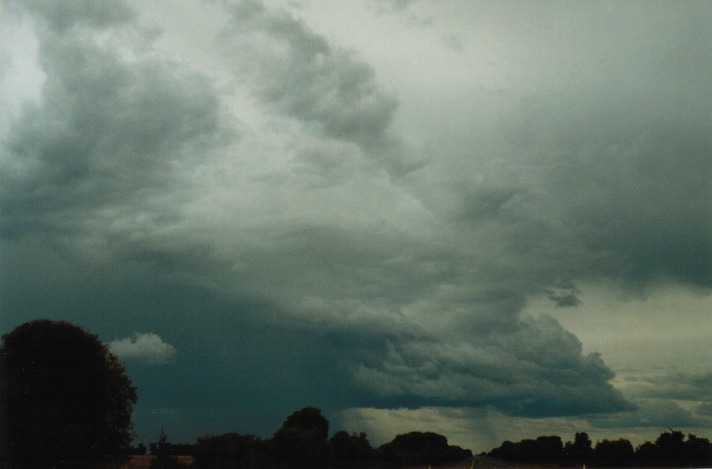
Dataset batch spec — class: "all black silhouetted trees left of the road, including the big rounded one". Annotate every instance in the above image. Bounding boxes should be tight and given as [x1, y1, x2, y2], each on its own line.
[0, 319, 472, 469]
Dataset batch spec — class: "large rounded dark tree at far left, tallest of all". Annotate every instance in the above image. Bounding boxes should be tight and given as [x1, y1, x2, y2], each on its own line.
[0, 320, 136, 469]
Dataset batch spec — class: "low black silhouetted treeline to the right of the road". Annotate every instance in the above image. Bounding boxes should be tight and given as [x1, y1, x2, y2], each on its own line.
[487, 429, 712, 467]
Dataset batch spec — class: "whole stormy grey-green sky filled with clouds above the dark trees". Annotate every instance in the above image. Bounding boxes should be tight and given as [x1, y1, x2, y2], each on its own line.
[0, 0, 712, 452]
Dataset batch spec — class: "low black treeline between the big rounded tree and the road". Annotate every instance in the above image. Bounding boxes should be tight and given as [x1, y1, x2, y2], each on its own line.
[136, 407, 472, 469]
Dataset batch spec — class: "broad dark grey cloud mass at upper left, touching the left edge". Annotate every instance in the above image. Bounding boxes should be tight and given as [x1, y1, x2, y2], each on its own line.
[1, 2, 234, 245]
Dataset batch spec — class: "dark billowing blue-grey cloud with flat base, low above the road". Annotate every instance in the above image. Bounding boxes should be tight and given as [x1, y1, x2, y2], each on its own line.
[342, 317, 634, 417]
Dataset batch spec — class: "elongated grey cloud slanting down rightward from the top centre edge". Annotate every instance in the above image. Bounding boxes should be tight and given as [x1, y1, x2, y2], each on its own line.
[222, 1, 419, 175]
